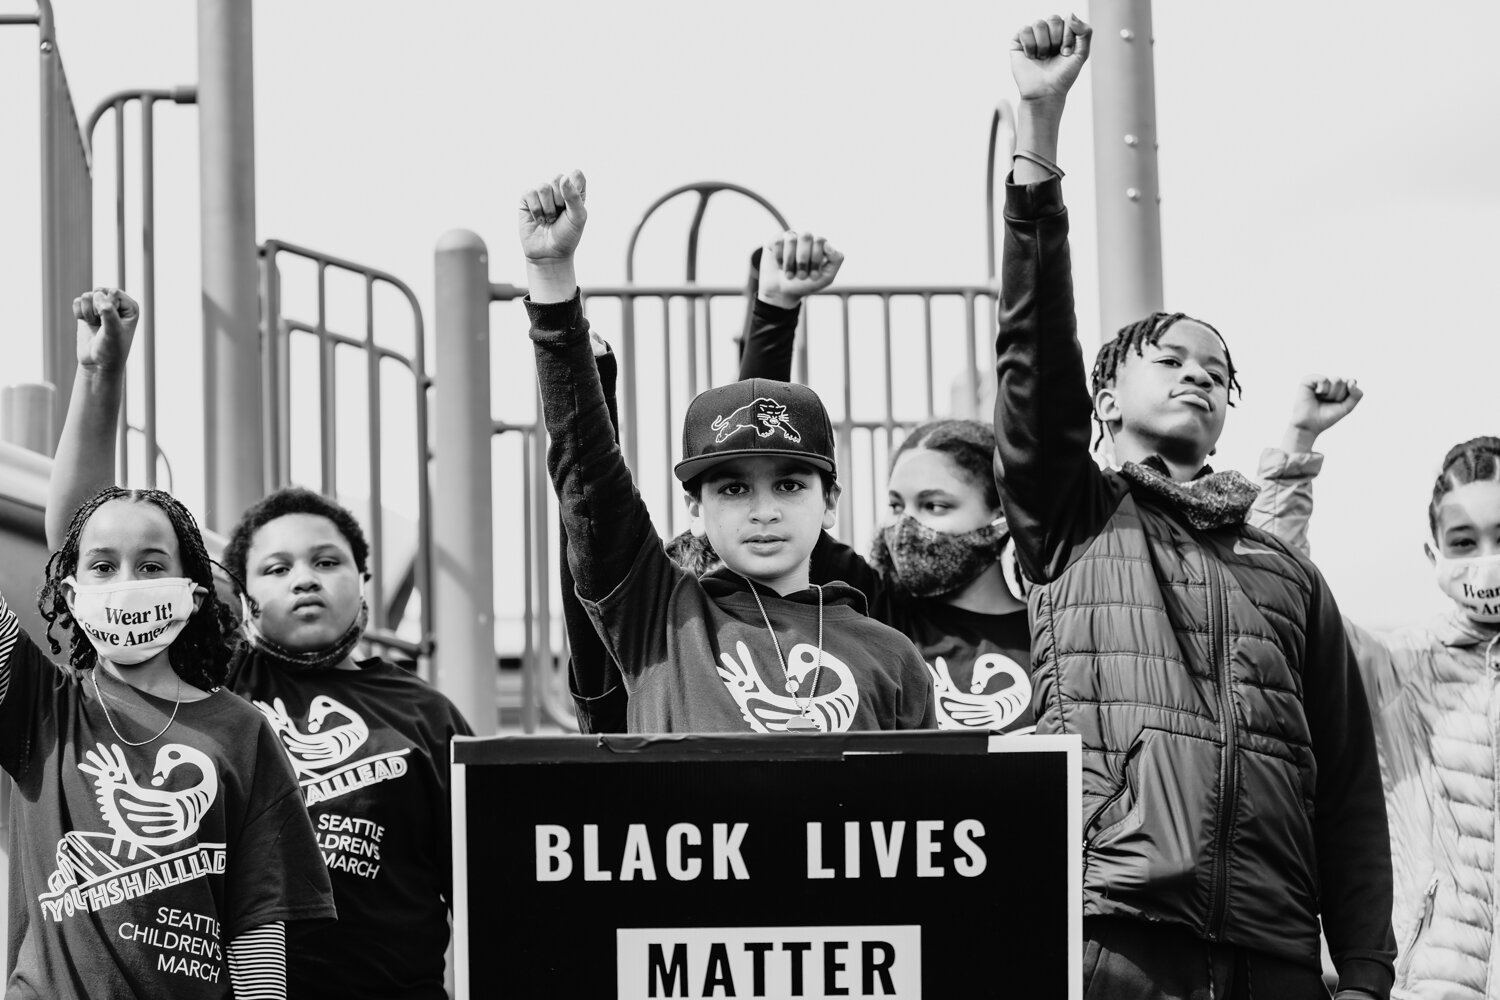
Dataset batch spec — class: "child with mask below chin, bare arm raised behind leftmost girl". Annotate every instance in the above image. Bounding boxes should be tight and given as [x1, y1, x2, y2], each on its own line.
[47, 289, 471, 1000]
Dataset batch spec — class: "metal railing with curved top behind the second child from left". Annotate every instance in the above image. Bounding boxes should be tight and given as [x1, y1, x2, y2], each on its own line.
[261, 240, 434, 672]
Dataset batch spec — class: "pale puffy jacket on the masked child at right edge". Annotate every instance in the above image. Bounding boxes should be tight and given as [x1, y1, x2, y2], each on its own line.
[1250, 448, 1500, 1000]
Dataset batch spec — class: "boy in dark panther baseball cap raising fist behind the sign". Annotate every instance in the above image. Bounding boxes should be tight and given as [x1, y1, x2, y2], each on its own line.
[519, 171, 936, 733]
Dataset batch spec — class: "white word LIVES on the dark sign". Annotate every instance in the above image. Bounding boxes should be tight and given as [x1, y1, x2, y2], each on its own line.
[807, 820, 989, 879]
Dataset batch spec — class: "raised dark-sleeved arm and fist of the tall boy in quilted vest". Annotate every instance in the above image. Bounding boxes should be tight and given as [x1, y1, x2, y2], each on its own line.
[995, 16, 1118, 583]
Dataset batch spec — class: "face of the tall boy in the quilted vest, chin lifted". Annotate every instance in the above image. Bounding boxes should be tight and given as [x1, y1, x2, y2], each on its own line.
[1094, 319, 1229, 463]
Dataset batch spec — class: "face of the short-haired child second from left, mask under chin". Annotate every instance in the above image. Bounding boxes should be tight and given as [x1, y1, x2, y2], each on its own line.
[245, 514, 362, 652]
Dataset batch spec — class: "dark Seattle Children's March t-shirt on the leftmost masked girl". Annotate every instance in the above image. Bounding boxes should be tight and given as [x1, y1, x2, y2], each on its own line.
[0, 600, 335, 1000]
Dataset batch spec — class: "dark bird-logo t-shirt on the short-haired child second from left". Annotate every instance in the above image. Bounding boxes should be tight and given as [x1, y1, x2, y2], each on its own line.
[230, 649, 473, 1000]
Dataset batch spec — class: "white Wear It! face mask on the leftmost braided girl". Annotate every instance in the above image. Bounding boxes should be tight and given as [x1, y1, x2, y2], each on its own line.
[63, 576, 197, 666]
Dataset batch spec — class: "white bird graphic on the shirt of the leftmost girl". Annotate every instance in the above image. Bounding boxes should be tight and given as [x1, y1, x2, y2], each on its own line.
[78, 744, 219, 859]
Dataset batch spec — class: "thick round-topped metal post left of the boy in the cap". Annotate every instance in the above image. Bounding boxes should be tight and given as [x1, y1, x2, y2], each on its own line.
[435, 229, 497, 736]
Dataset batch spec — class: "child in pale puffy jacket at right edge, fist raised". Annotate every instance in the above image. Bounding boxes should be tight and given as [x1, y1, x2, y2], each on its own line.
[1251, 375, 1500, 997]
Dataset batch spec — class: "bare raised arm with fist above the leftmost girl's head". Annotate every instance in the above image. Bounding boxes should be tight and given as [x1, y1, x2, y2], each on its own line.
[45, 288, 141, 549]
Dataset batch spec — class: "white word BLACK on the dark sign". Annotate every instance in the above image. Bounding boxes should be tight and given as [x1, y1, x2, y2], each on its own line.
[536, 823, 750, 882]
